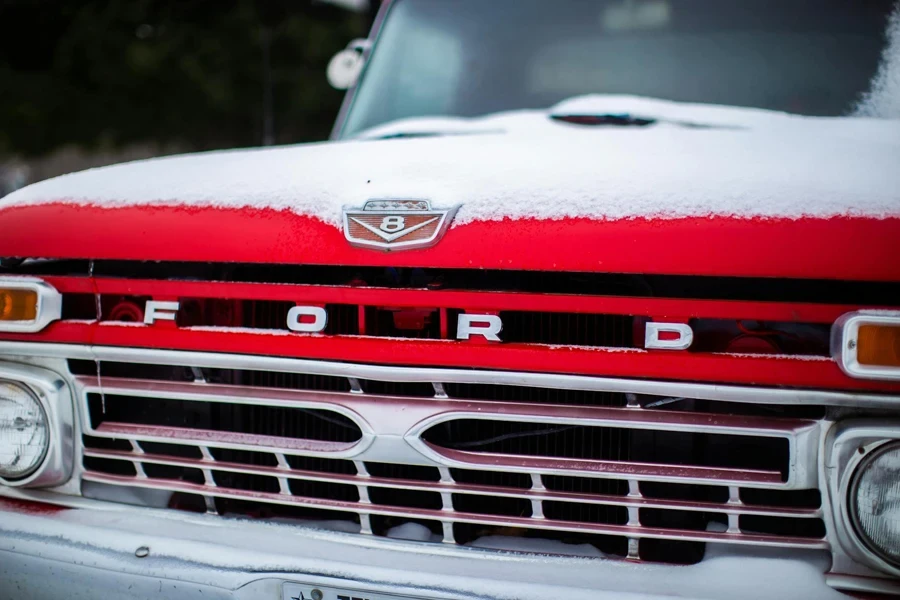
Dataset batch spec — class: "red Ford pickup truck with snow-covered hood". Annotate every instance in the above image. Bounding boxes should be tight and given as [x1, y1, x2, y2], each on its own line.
[0, 0, 900, 600]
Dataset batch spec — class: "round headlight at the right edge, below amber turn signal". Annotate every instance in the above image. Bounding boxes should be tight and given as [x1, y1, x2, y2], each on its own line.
[849, 443, 900, 566]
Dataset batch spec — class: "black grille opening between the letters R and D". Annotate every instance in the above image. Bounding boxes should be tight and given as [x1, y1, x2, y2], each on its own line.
[500, 311, 634, 348]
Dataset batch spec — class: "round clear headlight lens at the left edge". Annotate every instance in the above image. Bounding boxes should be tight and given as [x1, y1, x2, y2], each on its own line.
[0, 381, 50, 479]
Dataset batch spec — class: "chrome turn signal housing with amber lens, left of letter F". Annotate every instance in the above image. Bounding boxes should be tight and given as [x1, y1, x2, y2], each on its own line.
[0, 277, 62, 333]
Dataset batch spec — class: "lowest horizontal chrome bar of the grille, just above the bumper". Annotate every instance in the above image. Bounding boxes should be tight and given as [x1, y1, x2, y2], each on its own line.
[84, 472, 829, 549]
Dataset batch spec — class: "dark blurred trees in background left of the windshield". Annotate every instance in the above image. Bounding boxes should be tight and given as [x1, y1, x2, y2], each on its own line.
[0, 0, 378, 188]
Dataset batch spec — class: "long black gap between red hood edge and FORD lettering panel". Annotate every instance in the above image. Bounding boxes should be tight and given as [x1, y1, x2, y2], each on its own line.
[52, 260, 900, 306]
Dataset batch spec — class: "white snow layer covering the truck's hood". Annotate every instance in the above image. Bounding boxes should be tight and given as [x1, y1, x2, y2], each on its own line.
[0, 96, 900, 226]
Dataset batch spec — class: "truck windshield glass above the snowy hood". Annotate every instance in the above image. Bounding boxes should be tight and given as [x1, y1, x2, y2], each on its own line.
[342, 0, 894, 137]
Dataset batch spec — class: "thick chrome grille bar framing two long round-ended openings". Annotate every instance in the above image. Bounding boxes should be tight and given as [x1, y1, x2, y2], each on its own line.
[77, 377, 818, 488]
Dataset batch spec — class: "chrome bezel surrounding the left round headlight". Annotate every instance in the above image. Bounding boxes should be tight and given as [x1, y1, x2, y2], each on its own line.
[0, 363, 75, 488]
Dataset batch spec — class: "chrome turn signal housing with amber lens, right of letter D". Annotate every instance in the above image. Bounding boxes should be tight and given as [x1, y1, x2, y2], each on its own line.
[831, 311, 900, 380]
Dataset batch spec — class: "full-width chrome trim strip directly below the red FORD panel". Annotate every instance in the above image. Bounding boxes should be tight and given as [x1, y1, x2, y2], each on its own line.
[0, 341, 900, 409]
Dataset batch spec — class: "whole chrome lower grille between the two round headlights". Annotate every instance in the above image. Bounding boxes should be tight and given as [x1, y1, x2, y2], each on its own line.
[75, 354, 828, 562]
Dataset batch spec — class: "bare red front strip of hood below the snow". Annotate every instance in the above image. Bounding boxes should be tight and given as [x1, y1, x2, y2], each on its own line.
[0, 203, 900, 281]
